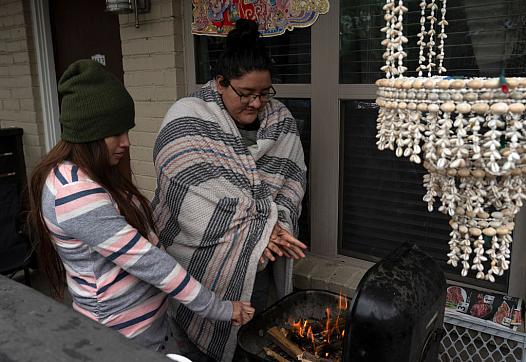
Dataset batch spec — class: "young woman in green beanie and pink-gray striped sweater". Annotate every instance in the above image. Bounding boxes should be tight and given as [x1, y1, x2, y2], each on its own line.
[30, 60, 253, 353]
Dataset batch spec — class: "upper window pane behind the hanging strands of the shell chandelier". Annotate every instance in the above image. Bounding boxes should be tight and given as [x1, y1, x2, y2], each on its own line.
[340, 0, 526, 84]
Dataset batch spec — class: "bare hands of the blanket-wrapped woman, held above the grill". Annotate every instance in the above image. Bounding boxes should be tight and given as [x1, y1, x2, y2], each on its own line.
[259, 224, 307, 264]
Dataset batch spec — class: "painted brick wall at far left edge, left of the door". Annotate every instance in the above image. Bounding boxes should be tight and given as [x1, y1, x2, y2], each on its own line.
[0, 0, 44, 175]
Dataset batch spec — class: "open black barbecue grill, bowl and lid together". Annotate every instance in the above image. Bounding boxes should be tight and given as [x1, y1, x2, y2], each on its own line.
[238, 244, 446, 362]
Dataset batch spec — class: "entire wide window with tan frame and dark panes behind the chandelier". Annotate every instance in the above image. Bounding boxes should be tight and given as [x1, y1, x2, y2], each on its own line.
[187, 0, 526, 297]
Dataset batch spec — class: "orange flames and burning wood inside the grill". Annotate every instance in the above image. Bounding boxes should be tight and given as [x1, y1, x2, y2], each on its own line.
[289, 293, 349, 357]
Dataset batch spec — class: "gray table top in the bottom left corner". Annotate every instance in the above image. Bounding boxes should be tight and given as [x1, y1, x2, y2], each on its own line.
[0, 275, 169, 362]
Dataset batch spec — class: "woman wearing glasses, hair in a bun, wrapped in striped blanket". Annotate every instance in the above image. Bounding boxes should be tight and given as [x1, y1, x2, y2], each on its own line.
[153, 20, 306, 361]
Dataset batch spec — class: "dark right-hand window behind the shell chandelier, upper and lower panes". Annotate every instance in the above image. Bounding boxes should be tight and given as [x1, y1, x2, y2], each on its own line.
[339, 0, 526, 291]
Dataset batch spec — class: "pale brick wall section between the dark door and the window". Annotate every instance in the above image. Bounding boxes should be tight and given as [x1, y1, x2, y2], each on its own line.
[119, 0, 185, 199]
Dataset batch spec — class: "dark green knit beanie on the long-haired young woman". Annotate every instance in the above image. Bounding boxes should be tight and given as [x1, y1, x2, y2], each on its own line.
[58, 59, 135, 143]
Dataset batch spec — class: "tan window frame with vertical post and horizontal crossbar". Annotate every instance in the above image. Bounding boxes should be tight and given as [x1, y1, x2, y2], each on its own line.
[183, 1, 526, 298]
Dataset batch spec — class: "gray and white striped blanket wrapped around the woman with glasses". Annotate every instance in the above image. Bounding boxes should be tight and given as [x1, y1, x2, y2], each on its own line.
[152, 82, 306, 361]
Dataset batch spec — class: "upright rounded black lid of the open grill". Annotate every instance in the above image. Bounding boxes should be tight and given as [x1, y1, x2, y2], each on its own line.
[343, 244, 446, 362]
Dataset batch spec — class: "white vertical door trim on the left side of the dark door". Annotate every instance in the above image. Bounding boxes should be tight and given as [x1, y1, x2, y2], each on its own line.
[31, 0, 60, 152]
